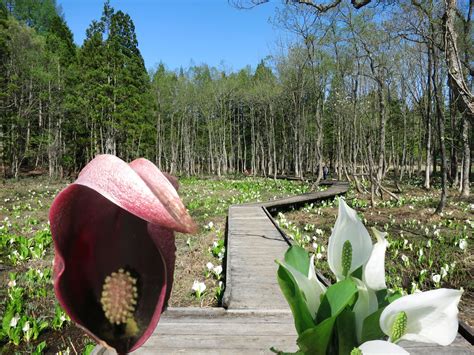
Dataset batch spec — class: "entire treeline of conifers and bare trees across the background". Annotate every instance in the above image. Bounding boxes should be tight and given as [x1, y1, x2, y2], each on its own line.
[0, 0, 474, 203]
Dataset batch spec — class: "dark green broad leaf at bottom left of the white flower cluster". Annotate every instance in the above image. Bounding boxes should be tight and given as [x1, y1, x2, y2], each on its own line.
[296, 317, 336, 355]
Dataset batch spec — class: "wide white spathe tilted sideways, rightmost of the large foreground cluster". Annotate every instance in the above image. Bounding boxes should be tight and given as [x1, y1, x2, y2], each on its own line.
[380, 288, 462, 345]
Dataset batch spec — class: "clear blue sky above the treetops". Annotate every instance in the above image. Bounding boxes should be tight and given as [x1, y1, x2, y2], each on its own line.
[57, 0, 285, 71]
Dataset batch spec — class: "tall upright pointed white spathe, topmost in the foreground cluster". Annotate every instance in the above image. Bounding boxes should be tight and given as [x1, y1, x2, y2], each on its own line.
[328, 197, 372, 281]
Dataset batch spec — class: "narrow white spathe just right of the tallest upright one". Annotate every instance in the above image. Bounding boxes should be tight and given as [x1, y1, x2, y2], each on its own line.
[362, 227, 388, 291]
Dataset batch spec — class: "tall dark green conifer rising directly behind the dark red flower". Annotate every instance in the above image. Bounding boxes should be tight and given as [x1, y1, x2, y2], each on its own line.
[78, 2, 153, 159]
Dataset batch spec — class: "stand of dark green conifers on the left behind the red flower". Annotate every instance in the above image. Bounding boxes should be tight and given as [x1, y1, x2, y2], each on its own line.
[0, 0, 153, 177]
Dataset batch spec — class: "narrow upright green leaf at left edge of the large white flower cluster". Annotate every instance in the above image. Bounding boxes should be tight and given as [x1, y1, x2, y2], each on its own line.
[277, 264, 314, 334]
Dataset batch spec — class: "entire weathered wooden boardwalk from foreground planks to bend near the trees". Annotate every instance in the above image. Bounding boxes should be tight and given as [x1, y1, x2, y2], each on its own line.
[93, 183, 474, 355]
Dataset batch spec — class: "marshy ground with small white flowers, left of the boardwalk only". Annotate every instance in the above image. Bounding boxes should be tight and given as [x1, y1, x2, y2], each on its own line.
[0, 178, 309, 354]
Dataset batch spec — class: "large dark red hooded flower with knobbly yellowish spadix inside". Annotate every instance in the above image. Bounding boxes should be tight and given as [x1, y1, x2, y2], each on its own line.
[49, 155, 196, 353]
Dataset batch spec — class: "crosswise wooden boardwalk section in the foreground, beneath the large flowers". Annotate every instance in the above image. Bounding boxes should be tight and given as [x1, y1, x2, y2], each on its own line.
[94, 308, 473, 355]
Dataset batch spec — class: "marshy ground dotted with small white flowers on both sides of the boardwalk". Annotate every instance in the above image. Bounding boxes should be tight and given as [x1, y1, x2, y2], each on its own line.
[0, 178, 474, 354]
